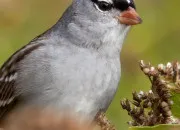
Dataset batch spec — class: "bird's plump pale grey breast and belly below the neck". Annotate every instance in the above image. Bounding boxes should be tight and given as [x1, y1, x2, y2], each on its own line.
[17, 43, 120, 117]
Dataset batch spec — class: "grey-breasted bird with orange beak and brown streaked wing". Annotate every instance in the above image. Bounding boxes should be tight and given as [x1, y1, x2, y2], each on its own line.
[0, 0, 142, 120]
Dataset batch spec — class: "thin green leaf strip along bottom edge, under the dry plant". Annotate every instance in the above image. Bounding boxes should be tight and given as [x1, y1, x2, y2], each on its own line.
[129, 125, 180, 130]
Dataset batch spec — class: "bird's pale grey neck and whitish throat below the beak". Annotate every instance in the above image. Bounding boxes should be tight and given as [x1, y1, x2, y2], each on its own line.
[66, 23, 129, 57]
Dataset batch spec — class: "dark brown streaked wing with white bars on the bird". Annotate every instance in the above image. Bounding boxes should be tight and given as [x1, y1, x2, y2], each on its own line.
[0, 43, 43, 119]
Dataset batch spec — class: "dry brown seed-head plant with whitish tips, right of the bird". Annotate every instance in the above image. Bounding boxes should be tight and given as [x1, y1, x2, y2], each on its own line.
[121, 61, 180, 126]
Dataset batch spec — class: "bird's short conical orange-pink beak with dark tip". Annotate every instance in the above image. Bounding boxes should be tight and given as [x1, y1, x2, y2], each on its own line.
[117, 7, 142, 25]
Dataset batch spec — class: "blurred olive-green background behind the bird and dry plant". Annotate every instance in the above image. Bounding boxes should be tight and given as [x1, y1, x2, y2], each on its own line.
[0, 0, 180, 130]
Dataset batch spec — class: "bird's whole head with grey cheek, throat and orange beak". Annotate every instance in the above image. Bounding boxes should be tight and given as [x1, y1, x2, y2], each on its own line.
[58, 0, 142, 50]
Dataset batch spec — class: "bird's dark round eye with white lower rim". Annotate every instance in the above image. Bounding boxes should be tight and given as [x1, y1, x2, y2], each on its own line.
[96, 1, 112, 11]
